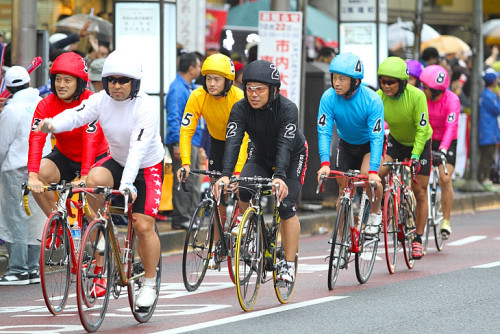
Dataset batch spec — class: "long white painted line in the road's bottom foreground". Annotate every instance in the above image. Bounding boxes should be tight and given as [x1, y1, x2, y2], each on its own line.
[152, 296, 348, 334]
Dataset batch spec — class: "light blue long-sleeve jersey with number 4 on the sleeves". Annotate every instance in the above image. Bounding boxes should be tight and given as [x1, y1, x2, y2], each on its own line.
[318, 86, 384, 171]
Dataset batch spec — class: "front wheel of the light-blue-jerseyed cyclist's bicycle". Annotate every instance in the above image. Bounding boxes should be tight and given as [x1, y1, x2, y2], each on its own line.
[328, 201, 349, 290]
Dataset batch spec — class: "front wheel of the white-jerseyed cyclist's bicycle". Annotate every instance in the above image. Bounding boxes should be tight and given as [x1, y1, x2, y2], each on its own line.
[76, 219, 112, 332]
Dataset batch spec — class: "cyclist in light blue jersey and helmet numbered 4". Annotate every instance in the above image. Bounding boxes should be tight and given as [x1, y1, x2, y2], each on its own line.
[317, 52, 384, 235]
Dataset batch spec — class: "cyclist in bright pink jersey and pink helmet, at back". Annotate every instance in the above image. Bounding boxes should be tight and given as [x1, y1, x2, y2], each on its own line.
[420, 65, 460, 239]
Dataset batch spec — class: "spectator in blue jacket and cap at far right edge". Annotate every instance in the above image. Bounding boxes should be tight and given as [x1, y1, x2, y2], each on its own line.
[479, 71, 500, 191]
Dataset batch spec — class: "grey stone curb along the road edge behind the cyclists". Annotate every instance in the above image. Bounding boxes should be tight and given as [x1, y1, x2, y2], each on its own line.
[0, 192, 500, 275]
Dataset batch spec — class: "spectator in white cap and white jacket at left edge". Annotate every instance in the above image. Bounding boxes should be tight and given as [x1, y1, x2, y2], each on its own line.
[0, 66, 50, 285]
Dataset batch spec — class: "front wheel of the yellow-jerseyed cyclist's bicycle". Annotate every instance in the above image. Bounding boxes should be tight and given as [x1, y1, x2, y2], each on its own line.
[182, 200, 215, 292]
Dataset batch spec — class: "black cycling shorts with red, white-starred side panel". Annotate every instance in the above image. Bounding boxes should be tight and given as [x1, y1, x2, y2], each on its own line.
[95, 156, 163, 217]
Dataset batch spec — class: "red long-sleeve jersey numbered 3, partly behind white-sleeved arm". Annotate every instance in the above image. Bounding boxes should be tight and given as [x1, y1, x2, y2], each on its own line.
[28, 89, 108, 175]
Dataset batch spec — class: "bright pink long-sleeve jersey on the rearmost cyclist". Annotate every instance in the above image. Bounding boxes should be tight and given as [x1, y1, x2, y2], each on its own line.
[427, 90, 460, 150]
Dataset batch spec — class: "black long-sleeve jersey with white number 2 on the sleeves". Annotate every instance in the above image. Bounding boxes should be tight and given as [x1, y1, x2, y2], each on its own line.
[222, 95, 306, 180]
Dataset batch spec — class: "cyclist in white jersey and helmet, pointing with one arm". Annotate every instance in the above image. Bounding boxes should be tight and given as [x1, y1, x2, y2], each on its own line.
[39, 50, 165, 307]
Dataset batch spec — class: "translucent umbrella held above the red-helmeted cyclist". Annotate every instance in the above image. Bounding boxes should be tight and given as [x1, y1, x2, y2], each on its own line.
[57, 14, 113, 42]
